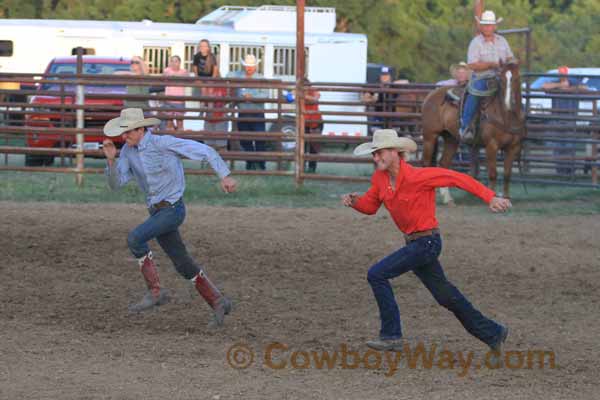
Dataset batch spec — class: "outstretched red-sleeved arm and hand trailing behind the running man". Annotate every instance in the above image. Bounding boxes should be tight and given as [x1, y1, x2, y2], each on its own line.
[418, 167, 512, 212]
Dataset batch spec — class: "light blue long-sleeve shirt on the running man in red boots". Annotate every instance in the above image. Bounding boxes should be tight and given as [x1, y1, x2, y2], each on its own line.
[105, 131, 230, 206]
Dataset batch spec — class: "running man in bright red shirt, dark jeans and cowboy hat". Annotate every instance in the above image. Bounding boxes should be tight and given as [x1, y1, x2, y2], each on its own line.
[342, 129, 511, 351]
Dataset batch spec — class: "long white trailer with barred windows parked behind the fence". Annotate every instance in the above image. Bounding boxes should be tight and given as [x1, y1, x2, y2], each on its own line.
[0, 6, 367, 136]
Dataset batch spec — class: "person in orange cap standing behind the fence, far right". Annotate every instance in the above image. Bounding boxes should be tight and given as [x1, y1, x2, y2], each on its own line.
[542, 66, 588, 175]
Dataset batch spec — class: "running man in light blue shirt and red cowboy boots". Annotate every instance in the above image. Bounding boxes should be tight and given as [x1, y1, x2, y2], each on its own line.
[102, 108, 236, 326]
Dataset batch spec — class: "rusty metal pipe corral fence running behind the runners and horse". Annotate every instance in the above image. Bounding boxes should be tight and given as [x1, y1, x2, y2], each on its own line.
[0, 61, 600, 188]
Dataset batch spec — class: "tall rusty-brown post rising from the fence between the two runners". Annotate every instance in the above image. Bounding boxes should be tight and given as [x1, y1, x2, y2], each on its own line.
[296, 0, 305, 186]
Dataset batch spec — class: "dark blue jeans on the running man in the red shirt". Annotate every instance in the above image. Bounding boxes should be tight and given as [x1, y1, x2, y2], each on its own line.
[367, 234, 501, 346]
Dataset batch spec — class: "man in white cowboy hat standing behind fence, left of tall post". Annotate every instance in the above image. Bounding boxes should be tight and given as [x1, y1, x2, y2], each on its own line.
[227, 54, 269, 170]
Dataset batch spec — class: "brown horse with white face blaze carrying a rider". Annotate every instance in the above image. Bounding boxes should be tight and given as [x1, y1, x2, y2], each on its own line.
[422, 63, 526, 204]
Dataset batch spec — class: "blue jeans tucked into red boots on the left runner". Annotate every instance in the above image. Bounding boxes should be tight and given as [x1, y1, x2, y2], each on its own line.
[127, 199, 201, 279]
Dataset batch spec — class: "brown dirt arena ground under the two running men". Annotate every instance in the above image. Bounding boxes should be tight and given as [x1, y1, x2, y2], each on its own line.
[0, 202, 600, 400]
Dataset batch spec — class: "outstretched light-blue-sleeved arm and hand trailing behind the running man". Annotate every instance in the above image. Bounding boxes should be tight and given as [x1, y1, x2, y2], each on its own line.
[160, 135, 237, 193]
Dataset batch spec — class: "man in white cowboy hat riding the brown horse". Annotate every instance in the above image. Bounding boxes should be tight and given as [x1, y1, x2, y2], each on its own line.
[459, 10, 514, 140]
